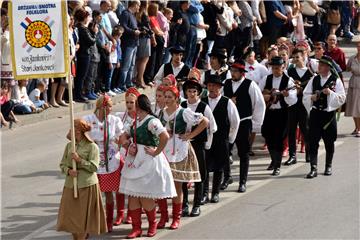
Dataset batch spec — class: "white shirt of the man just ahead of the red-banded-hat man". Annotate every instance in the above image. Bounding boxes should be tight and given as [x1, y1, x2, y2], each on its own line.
[208, 95, 240, 143]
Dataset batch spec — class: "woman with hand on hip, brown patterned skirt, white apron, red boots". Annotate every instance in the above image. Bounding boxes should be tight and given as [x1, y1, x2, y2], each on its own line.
[158, 86, 209, 229]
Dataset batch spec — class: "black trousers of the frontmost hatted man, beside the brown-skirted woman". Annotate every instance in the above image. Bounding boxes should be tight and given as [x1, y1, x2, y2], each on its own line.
[182, 141, 207, 207]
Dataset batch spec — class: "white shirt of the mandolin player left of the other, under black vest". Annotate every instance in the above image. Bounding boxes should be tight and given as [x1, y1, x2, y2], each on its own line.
[259, 75, 297, 109]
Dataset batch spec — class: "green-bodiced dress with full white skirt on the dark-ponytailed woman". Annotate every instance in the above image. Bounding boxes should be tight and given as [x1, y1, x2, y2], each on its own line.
[119, 115, 176, 199]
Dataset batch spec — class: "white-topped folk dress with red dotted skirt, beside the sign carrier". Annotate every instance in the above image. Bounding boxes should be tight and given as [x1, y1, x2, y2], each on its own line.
[84, 114, 124, 192]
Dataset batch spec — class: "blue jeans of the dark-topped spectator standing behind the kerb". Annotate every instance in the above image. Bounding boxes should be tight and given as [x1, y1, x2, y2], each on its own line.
[120, 47, 137, 89]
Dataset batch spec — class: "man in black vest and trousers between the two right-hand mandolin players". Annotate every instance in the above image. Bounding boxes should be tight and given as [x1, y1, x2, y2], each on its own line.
[284, 48, 314, 165]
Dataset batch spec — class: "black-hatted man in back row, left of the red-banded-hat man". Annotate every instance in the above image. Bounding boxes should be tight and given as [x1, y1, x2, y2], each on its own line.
[201, 48, 231, 83]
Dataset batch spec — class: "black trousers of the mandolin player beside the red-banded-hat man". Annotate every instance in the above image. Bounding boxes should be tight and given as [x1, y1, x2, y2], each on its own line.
[261, 108, 288, 168]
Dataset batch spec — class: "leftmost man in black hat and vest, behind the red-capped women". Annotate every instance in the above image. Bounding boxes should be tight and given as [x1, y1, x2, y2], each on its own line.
[154, 46, 190, 85]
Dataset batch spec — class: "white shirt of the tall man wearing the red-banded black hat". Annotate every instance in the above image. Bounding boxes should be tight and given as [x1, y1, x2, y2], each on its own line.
[231, 79, 266, 132]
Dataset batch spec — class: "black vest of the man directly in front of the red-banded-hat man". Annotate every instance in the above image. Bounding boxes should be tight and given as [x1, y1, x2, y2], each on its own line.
[202, 96, 230, 142]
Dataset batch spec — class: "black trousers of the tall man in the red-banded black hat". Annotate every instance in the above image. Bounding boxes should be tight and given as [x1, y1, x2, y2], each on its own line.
[224, 119, 252, 183]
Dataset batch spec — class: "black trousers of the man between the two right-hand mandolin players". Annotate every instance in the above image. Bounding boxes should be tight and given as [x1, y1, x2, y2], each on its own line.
[288, 102, 309, 156]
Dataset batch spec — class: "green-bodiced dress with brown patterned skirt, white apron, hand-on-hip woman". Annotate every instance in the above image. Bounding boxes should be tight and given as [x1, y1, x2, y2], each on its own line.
[159, 107, 203, 182]
